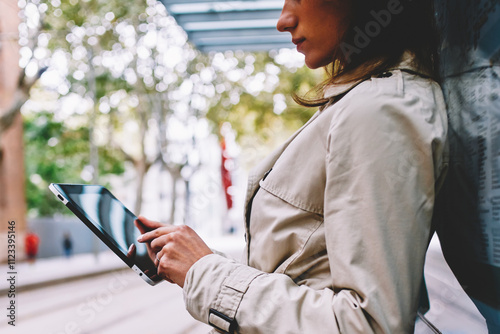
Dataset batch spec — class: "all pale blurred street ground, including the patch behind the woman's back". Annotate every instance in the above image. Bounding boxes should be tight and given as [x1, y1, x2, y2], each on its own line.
[0, 237, 487, 334]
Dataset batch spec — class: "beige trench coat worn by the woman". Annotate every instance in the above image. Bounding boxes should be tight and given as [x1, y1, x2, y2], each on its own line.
[184, 56, 447, 334]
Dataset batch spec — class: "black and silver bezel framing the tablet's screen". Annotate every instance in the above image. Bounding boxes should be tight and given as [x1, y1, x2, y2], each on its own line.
[49, 183, 162, 285]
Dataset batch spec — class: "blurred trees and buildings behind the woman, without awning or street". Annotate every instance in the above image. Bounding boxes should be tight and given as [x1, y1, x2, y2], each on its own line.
[0, 0, 322, 258]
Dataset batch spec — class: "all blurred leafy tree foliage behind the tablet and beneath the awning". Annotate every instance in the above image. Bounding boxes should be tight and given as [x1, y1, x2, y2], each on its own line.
[20, 0, 322, 215]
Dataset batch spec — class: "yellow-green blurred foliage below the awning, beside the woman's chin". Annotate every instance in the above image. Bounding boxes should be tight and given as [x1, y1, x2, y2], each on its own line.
[206, 52, 323, 168]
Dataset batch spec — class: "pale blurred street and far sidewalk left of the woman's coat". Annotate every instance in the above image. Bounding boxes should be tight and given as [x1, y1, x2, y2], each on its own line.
[0, 235, 244, 334]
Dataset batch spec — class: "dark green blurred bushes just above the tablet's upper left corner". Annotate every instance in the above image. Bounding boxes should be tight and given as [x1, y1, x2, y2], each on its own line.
[24, 112, 124, 216]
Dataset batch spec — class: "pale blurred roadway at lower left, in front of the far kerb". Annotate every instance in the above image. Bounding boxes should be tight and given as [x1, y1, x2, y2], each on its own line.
[0, 269, 208, 334]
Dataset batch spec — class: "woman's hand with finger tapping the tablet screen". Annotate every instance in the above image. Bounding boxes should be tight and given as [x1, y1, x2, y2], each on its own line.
[137, 217, 213, 288]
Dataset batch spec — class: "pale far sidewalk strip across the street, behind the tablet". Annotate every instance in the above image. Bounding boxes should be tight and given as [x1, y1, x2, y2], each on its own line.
[0, 235, 244, 295]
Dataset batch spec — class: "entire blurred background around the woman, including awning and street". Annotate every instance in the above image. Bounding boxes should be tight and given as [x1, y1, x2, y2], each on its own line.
[0, 0, 494, 334]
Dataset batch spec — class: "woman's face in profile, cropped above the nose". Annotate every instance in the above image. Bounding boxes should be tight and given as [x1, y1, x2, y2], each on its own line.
[277, 0, 349, 68]
